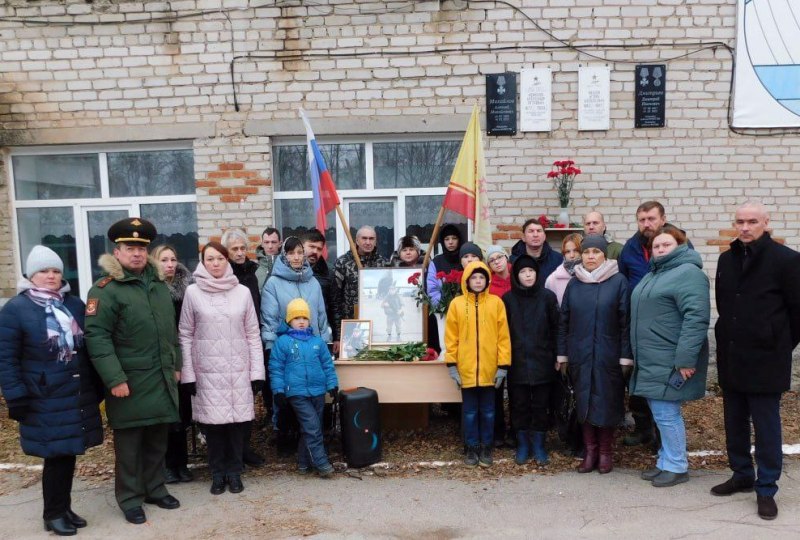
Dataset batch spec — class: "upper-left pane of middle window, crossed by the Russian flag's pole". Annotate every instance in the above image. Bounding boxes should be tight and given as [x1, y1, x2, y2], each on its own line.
[273, 143, 367, 191]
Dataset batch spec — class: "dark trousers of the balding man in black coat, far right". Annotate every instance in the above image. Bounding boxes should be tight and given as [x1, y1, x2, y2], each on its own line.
[722, 390, 783, 497]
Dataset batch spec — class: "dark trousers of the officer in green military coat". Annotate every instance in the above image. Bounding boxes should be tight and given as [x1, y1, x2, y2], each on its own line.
[114, 424, 169, 511]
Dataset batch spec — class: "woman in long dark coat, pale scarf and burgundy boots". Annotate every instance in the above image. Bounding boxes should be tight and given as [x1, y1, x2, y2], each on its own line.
[558, 235, 633, 473]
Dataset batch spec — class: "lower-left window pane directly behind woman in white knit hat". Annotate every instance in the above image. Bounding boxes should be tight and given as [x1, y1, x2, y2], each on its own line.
[17, 207, 80, 295]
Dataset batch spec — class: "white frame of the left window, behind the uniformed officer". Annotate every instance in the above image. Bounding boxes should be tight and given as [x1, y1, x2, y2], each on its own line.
[7, 140, 197, 300]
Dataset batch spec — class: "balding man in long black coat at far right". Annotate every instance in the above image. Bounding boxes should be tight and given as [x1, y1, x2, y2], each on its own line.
[711, 202, 800, 519]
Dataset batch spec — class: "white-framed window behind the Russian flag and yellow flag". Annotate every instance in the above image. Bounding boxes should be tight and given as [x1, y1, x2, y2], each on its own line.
[273, 136, 466, 264]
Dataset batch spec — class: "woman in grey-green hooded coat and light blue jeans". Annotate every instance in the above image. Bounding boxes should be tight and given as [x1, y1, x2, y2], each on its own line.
[630, 225, 711, 487]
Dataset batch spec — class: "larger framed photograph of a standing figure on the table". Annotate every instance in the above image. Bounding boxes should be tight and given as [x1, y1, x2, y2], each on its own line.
[358, 268, 427, 346]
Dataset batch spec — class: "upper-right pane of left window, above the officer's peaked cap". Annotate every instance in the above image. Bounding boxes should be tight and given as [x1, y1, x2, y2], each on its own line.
[106, 150, 195, 197]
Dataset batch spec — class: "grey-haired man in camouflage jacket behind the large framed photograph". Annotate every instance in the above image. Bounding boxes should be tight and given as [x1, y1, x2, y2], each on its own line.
[333, 225, 389, 352]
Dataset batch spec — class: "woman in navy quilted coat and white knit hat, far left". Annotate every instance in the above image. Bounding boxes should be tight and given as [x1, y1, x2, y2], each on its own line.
[0, 246, 103, 536]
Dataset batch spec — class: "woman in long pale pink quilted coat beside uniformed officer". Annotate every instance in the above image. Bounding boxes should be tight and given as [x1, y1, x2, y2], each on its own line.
[178, 242, 265, 495]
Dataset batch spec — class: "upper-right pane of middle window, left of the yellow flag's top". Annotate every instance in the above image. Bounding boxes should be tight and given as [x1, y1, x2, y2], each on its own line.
[372, 141, 460, 189]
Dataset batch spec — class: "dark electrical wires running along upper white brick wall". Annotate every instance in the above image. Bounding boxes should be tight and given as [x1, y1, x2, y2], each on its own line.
[0, 0, 800, 137]
